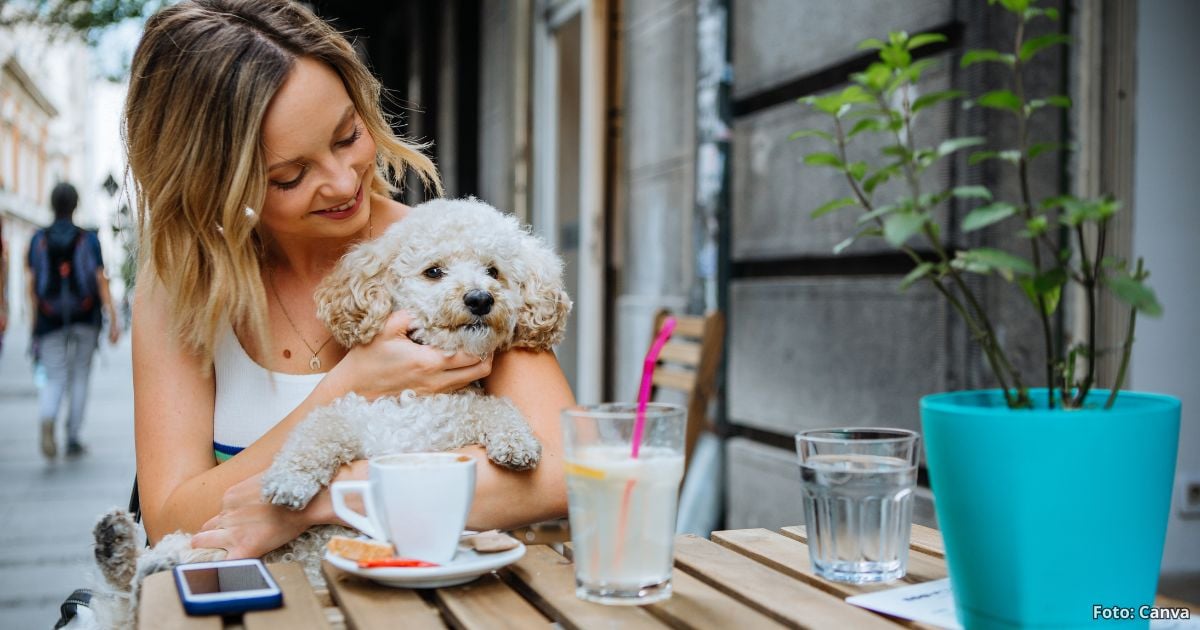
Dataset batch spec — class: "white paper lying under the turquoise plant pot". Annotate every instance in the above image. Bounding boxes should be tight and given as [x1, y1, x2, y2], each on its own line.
[846, 577, 1200, 630]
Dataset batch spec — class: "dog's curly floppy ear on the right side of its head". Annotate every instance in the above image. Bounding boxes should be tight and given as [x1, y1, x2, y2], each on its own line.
[511, 234, 571, 350]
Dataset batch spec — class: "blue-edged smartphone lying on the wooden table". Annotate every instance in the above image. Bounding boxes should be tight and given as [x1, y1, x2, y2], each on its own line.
[175, 558, 283, 614]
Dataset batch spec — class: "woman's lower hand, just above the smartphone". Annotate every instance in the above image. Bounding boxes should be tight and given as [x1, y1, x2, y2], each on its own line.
[192, 474, 309, 559]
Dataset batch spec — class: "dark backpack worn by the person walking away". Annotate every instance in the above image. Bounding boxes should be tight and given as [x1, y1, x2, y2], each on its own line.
[29, 227, 100, 324]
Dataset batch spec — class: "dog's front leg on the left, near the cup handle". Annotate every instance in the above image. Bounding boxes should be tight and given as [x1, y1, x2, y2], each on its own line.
[256, 394, 367, 510]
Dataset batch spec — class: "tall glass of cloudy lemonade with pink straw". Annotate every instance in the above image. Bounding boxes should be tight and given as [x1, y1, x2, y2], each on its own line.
[563, 403, 686, 605]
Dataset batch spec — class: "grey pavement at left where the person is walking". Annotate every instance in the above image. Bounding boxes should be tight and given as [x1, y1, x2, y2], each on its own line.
[0, 322, 134, 629]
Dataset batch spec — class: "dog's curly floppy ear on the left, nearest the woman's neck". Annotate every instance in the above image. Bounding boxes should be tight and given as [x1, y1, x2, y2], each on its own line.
[313, 235, 392, 348]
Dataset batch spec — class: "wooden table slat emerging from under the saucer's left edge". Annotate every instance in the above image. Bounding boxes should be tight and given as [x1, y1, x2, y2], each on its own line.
[320, 562, 446, 630]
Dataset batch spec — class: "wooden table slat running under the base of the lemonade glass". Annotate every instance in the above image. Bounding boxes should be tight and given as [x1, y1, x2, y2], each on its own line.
[500, 545, 664, 629]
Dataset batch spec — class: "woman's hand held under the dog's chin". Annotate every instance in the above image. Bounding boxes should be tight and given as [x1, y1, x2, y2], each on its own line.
[334, 311, 492, 400]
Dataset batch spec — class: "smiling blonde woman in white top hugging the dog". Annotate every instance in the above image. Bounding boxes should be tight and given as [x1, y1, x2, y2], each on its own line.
[125, 0, 572, 558]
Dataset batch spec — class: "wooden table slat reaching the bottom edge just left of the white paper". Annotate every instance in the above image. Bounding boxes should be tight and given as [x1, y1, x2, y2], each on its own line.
[676, 534, 896, 629]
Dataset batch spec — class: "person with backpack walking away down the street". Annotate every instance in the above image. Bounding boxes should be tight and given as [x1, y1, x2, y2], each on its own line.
[25, 182, 121, 458]
